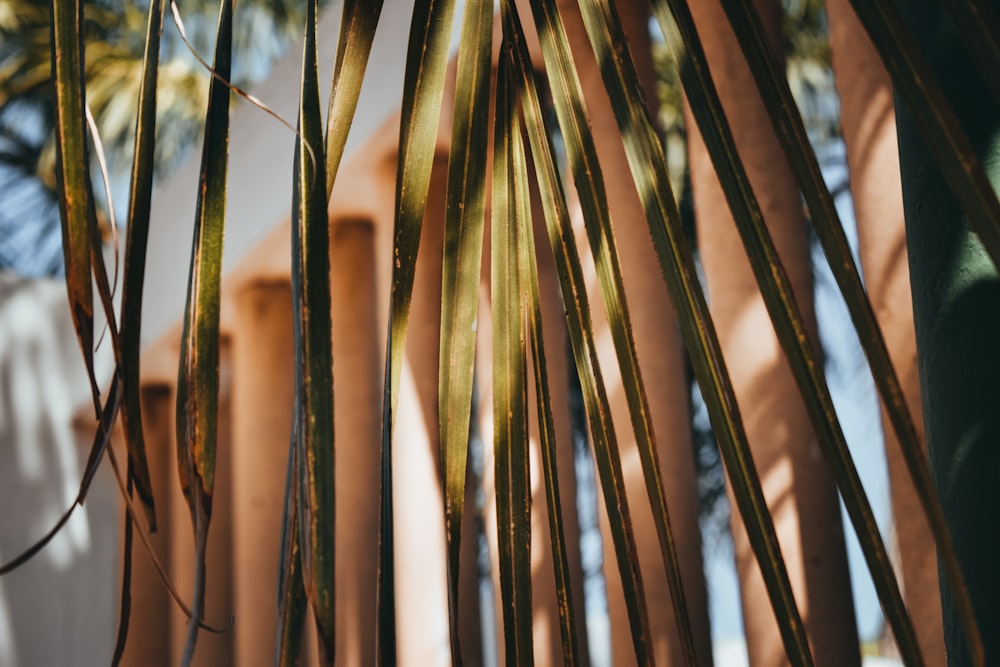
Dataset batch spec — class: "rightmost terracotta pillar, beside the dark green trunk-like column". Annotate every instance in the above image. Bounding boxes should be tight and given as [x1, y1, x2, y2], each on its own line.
[827, 0, 944, 664]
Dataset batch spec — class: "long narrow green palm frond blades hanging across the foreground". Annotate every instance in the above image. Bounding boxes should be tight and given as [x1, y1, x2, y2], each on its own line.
[21, 0, 1000, 665]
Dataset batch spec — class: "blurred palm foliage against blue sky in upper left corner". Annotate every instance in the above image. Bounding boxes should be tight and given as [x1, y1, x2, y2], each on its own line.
[0, 0, 322, 275]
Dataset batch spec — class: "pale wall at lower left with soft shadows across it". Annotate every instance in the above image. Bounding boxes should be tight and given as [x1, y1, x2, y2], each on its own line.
[0, 274, 120, 667]
